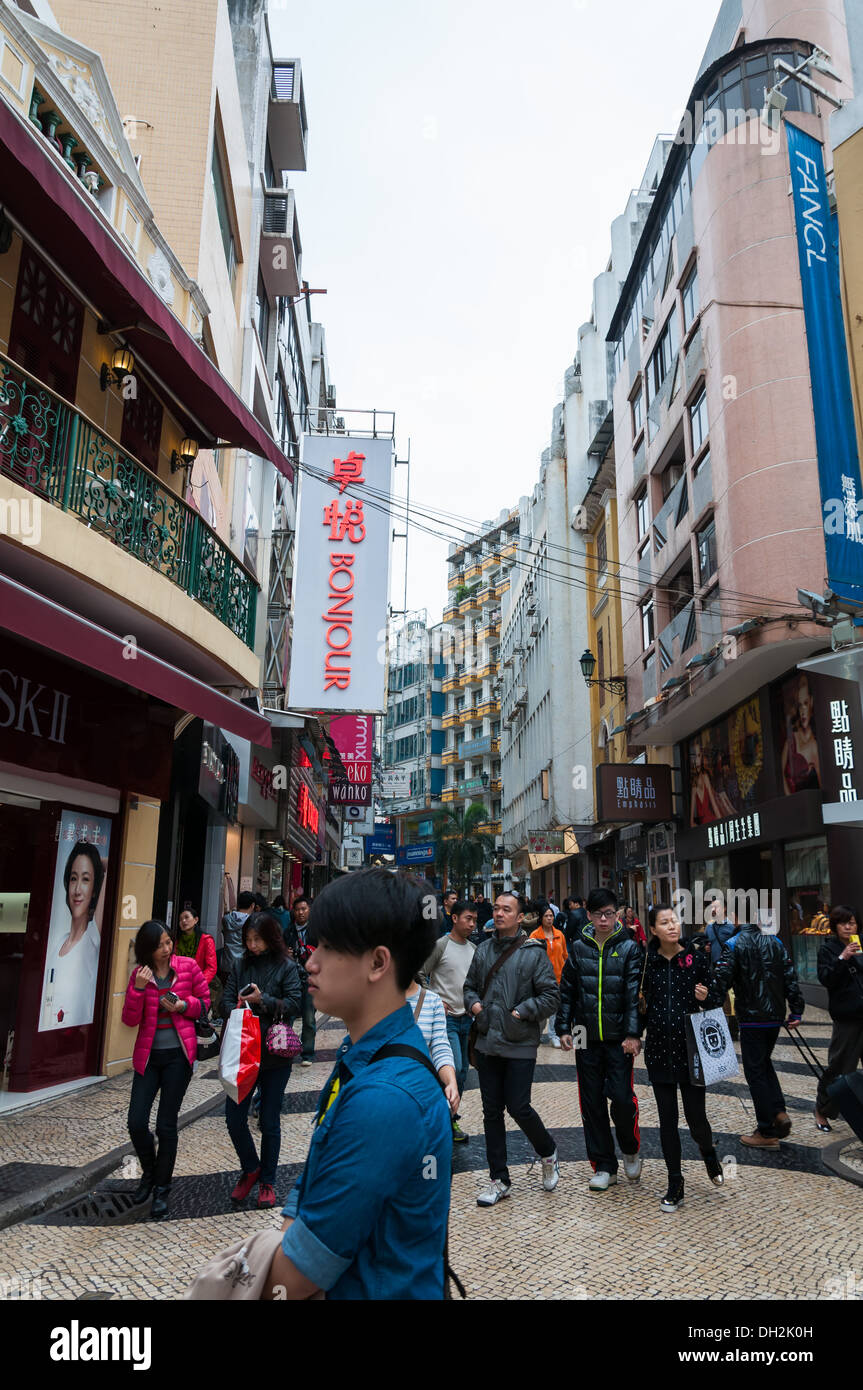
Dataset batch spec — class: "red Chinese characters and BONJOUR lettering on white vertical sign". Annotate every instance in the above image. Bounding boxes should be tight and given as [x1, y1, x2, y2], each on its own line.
[321, 449, 365, 691]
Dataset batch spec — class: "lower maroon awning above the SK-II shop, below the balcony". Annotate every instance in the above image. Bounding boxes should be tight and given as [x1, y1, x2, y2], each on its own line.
[0, 574, 272, 748]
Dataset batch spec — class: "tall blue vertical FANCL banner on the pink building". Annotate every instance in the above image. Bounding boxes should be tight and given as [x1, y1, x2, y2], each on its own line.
[785, 121, 863, 603]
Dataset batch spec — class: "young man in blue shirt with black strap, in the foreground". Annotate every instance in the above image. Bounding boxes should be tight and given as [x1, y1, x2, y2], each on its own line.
[262, 869, 452, 1300]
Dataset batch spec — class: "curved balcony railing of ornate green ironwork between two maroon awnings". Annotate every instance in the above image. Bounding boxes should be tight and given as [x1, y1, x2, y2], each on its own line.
[0, 353, 258, 648]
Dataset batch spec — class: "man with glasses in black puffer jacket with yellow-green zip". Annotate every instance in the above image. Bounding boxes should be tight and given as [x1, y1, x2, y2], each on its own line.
[554, 888, 645, 1193]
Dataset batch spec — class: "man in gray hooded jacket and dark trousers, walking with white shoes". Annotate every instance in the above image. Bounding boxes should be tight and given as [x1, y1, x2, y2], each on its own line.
[464, 892, 560, 1207]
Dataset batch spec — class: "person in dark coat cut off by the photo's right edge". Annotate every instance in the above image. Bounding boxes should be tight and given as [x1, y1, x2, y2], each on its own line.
[816, 906, 863, 1134]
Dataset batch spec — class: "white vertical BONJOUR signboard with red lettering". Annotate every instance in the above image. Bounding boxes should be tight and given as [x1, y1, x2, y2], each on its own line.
[288, 435, 392, 714]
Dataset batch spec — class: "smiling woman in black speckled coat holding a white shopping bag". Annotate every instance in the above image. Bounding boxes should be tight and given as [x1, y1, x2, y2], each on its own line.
[639, 904, 723, 1212]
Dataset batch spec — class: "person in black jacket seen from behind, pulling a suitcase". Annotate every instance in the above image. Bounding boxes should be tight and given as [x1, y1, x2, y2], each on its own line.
[709, 923, 806, 1148]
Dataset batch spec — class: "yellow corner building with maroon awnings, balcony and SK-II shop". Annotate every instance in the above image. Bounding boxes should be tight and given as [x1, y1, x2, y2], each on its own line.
[0, 3, 290, 1091]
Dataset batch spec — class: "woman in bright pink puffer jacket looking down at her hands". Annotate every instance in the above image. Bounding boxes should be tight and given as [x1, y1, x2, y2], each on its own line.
[122, 922, 210, 1220]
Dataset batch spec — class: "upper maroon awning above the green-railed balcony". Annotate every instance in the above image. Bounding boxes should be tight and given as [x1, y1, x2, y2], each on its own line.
[0, 99, 293, 478]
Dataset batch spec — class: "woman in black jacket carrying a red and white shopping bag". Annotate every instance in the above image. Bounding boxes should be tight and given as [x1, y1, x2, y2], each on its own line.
[222, 912, 302, 1207]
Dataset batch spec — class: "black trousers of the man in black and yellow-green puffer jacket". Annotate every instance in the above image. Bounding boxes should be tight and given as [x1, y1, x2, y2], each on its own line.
[575, 1040, 641, 1173]
